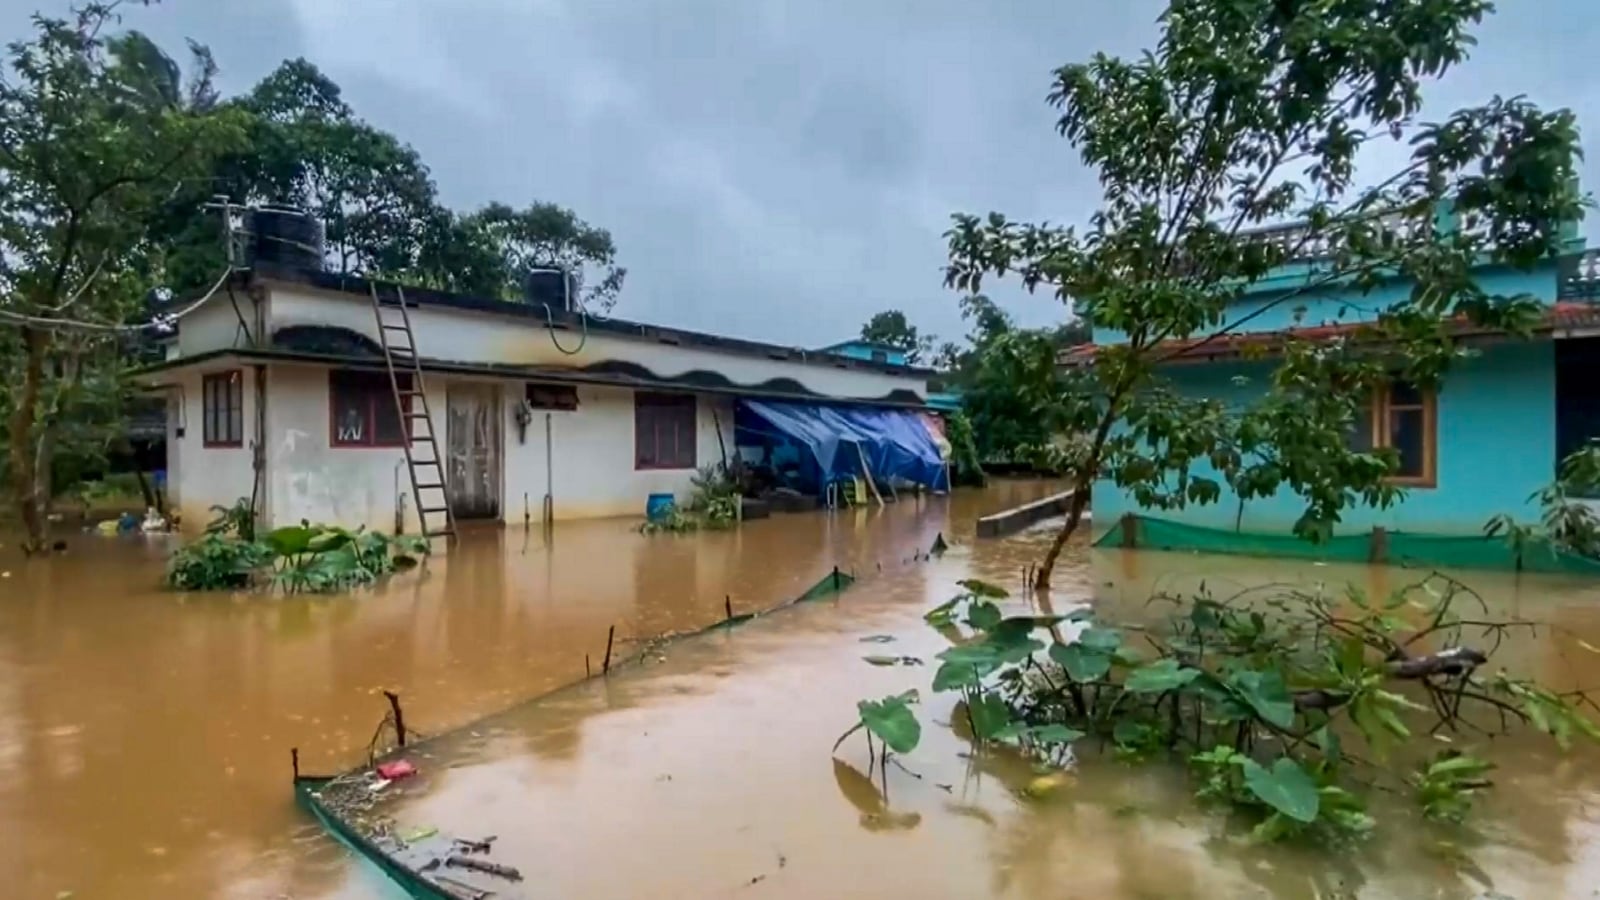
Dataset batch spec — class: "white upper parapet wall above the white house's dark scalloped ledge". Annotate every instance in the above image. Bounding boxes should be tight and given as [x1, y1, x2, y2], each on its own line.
[262, 285, 926, 399]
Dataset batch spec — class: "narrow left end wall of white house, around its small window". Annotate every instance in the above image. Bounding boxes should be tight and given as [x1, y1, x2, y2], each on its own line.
[165, 367, 259, 528]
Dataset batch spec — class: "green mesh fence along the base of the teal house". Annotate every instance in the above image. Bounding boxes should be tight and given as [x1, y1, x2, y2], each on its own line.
[1094, 516, 1600, 575]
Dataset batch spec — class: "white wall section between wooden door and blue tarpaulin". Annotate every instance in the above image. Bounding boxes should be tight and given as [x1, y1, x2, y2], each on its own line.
[502, 383, 733, 522]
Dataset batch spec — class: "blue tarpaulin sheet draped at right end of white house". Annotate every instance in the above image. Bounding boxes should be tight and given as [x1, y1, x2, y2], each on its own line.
[736, 399, 947, 488]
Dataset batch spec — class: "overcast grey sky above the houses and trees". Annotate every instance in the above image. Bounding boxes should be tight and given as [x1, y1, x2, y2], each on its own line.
[9, 0, 1600, 346]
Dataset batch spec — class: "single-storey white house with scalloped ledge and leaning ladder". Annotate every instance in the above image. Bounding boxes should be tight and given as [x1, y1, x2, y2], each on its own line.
[142, 259, 928, 533]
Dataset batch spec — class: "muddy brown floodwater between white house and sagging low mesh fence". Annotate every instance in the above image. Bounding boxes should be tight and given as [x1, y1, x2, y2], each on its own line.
[0, 480, 1056, 900]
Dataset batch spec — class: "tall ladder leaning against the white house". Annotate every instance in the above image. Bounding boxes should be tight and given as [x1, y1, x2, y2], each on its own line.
[371, 285, 456, 540]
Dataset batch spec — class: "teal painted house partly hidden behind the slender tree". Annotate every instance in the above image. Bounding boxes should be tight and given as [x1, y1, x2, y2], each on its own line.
[1061, 212, 1600, 536]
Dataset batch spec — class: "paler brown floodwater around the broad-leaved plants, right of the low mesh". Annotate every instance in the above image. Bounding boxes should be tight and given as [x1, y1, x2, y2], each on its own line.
[366, 530, 1600, 900]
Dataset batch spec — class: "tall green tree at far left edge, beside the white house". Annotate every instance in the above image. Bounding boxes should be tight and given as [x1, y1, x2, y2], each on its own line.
[0, 3, 242, 548]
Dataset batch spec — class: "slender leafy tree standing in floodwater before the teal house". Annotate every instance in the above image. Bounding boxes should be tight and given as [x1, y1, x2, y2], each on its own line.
[947, 0, 1582, 588]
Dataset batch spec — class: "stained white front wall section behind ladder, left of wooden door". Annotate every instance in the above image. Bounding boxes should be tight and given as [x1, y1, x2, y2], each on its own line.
[267, 358, 445, 535]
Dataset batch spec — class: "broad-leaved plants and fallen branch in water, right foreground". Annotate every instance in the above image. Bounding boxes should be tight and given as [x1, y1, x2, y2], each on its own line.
[835, 573, 1600, 841]
